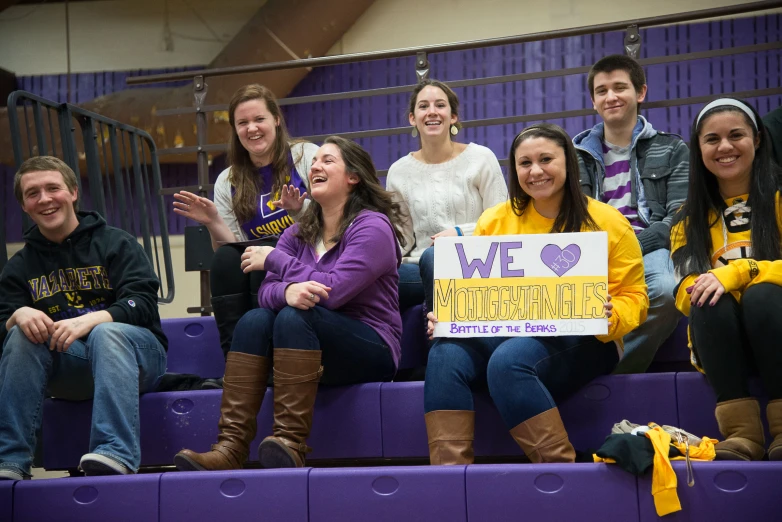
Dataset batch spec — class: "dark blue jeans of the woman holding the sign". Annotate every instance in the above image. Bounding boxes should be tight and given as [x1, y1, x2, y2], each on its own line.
[424, 336, 619, 430]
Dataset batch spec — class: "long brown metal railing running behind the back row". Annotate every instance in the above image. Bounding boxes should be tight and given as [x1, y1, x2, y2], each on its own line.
[122, 0, 782, 314]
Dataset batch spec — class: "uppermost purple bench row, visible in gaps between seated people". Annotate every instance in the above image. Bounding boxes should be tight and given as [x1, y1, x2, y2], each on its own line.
[162, 306, 691, 377]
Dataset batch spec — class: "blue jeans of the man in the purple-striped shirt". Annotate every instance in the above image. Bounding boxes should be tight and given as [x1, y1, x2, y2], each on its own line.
[614, 248, 682, 373]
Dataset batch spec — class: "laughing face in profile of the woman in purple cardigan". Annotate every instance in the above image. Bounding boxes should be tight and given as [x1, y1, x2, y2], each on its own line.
[309, 143, 359, 207]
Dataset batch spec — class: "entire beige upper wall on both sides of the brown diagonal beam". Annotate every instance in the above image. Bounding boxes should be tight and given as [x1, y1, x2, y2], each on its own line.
[0, 0, 776, 74]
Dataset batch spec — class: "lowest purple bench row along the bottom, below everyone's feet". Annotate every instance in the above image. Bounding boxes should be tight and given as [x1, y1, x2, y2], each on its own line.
[0, 462, 782, 522]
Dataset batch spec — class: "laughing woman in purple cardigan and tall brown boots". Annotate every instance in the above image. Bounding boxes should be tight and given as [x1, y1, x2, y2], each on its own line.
[174, 136, 404, 471]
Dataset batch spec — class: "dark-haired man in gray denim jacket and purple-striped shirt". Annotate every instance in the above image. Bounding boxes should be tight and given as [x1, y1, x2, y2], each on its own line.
[573, 55, 689, 373]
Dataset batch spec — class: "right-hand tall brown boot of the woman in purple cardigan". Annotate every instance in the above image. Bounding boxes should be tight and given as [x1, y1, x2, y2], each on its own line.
[258, 348, 323, 468]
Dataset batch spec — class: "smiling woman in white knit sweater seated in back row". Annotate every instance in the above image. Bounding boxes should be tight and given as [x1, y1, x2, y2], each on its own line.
[386, 80, 508, 310]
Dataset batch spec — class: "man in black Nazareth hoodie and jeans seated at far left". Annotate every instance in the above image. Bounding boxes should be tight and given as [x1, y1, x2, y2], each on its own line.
[0, 156, 167, 480]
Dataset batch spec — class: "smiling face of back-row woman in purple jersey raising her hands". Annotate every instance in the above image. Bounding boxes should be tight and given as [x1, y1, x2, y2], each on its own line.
[234, 99, 280, 167]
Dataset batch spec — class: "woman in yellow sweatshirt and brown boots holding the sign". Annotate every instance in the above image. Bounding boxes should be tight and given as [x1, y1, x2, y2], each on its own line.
[424, 123, 649, 464]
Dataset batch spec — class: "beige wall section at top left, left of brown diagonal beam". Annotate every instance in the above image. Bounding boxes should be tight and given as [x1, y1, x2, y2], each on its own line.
[0, 0, 266, 75]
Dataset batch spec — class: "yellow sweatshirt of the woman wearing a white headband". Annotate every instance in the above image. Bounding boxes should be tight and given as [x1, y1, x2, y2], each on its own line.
[671, 192, 782, 371]
